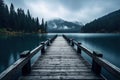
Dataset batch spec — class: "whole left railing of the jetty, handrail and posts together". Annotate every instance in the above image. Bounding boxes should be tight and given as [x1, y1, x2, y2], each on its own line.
[0, 35, 57, 80]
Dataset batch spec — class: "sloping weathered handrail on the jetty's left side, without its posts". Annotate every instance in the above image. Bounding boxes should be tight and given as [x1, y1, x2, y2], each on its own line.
[0, 35, 57, 80]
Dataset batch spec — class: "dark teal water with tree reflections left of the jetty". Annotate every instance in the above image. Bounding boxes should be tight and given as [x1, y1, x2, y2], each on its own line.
[0, 34, 47, 72]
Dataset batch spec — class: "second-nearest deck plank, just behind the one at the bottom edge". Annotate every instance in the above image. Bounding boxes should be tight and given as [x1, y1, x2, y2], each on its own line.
[29, 69, 96, 76]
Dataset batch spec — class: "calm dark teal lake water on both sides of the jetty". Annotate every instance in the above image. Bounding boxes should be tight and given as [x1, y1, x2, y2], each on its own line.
[0, 33, 120, 80]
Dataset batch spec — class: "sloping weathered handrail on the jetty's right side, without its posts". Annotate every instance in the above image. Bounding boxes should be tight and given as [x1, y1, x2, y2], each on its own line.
[63, 35, 120, 79]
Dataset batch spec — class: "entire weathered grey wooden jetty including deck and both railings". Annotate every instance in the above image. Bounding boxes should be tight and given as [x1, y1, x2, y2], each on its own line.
[0, 35, 120, 80]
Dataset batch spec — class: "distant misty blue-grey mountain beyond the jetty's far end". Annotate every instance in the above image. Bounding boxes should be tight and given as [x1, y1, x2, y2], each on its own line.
[47, 19, 83, 33]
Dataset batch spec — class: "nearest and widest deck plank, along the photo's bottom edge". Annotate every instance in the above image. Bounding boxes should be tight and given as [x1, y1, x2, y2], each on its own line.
[20, 75, 103, 80]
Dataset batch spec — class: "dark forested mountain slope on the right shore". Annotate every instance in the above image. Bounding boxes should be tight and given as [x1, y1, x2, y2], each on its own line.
[81, 10, 120, 33]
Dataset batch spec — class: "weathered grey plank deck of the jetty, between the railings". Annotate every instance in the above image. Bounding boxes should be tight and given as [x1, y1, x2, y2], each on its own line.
[19, 36, 103, 80]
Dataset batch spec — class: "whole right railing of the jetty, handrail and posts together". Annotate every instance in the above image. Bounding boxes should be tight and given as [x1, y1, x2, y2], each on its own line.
[63, 35, 120, 79]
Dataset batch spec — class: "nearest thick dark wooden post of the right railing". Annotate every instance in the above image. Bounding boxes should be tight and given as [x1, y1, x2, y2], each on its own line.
[92, 51, 103, 75]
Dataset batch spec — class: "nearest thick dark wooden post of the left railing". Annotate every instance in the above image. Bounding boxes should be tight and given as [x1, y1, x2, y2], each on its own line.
[20, 50, 31, 76]
